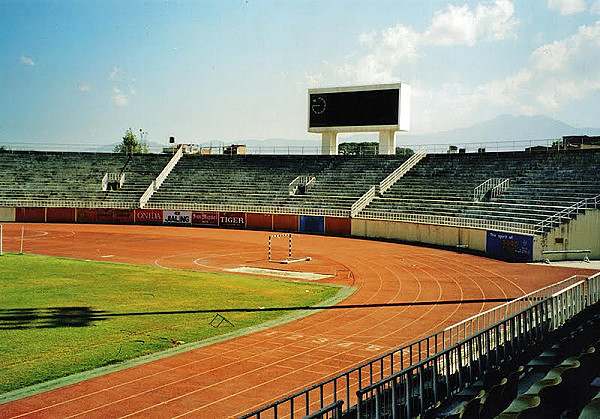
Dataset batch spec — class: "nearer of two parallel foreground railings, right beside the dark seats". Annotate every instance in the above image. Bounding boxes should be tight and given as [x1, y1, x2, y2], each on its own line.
[357, 274, 600, 418]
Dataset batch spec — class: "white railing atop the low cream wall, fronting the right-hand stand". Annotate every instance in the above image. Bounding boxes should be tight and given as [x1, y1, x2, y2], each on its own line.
[355, 210, 538, 235]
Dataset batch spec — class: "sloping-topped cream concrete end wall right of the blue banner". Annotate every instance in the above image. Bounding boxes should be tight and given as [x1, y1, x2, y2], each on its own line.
[533, 210, 600, 260]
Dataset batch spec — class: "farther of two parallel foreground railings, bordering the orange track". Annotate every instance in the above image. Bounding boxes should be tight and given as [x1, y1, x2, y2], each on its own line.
[242, 274, 600, 419]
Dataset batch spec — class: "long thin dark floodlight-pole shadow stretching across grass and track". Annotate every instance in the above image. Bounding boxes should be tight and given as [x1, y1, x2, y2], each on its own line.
[0, 298, 512, 330]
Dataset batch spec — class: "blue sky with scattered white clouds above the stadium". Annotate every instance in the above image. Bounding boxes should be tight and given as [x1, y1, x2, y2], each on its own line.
[0, 0, 600, 148]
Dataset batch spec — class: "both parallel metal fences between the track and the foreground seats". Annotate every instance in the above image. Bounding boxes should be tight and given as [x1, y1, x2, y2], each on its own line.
[242, 274, 600, 419]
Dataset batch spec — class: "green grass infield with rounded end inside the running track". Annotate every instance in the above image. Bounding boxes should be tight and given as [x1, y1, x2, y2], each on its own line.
[0, 254, 339, 393]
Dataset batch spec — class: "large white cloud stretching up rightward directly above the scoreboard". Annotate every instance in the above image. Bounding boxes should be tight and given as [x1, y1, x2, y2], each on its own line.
[326, 0, 518, 83]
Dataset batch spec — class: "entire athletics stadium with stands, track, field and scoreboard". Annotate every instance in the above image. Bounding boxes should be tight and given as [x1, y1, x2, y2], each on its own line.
[0, 85, 600, 418]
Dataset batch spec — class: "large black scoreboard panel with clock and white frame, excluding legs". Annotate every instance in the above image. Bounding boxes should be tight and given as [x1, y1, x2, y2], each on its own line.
[308, 84, 410, 132]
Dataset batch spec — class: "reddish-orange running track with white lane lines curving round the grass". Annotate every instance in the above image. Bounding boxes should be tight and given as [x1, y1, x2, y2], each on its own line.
[0, 224, 589, 418]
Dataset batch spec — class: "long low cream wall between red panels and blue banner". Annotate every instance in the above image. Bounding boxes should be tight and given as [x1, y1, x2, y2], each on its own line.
[352, 218, 486, 252]
